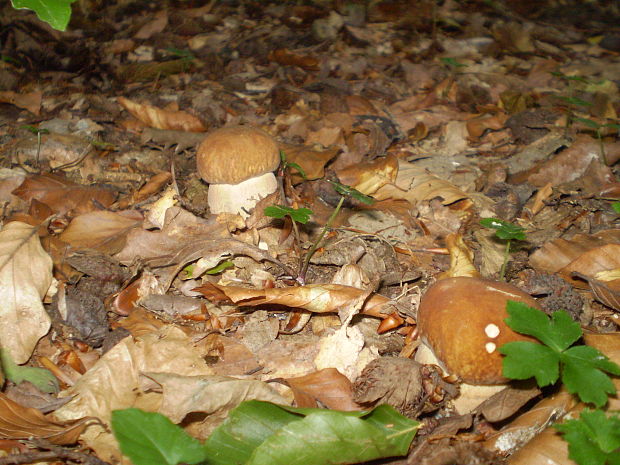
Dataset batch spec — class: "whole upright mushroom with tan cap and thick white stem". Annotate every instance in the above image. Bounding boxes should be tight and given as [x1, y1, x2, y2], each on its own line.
[196, 126, 280, 218]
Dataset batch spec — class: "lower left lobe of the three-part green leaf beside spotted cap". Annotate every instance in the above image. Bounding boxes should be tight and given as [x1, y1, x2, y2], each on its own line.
[499, 341, 560, 387]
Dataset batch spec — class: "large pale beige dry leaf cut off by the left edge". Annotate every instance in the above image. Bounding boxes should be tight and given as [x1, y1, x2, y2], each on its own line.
[0, 221, 52, 364]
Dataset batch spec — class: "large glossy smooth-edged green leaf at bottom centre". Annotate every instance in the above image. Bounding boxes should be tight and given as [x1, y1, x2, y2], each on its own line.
[205, 401, 419, 465]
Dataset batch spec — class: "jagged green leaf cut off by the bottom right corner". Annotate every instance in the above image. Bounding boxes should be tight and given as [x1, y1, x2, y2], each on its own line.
[554, 409, 620, 465]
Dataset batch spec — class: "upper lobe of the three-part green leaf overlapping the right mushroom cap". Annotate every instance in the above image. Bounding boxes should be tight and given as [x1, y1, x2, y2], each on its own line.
[506, 300, 582, 352]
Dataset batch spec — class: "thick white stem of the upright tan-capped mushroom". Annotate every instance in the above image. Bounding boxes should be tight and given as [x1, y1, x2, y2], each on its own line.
[207, 172, 278, 218]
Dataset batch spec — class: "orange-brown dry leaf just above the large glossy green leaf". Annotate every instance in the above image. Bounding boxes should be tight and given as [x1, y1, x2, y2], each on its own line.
[282, 368, 361, 411]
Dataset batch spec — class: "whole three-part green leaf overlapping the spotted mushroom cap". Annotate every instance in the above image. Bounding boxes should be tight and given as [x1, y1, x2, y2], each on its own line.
[499, 301, 620, 407]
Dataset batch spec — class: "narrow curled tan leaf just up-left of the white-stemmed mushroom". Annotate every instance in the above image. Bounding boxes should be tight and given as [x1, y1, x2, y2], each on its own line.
[118, 97, 207, 132]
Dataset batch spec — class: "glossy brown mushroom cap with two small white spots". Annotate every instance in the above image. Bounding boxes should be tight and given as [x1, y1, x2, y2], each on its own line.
[418, 277, 539, 385]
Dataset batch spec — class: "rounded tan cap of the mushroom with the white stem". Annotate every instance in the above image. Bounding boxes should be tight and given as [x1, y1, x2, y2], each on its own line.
[196, 126, 280, 184]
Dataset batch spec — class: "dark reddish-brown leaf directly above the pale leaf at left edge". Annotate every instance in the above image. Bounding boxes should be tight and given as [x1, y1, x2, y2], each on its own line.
[13, 174, 115, 215]
